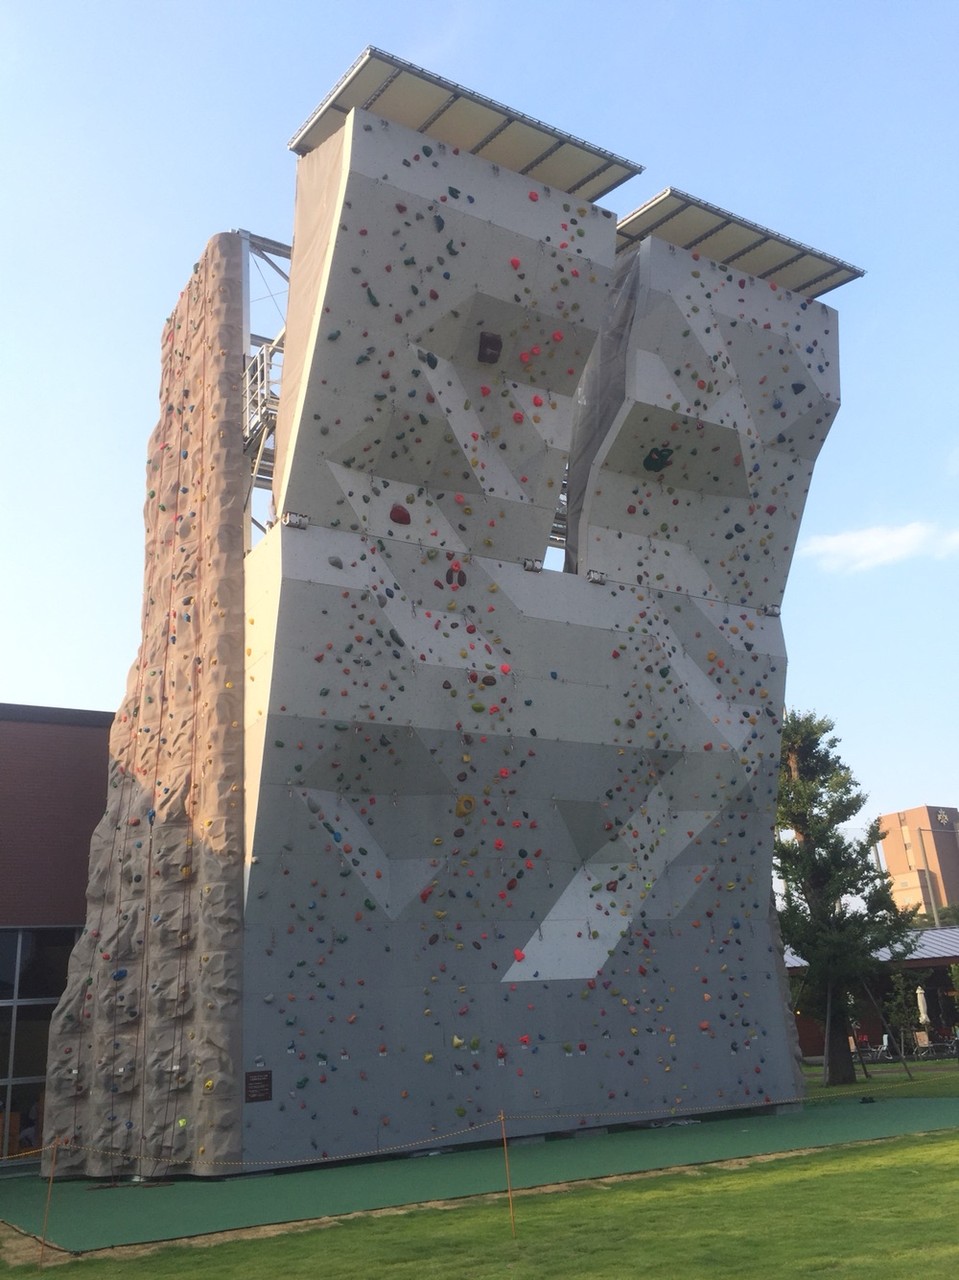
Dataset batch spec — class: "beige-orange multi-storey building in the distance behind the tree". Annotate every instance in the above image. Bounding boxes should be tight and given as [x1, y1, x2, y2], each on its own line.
[880, 805, 959, 915]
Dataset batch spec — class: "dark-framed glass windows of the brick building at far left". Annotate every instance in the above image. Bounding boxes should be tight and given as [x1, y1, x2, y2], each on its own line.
[0, 929, 79, 1161]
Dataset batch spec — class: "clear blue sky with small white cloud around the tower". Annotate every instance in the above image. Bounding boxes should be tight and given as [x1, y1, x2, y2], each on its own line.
[0, 0, 959, 817]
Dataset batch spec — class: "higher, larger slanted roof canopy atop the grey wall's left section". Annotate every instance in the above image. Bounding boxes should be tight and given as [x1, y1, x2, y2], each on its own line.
[289, 45, 643, 201]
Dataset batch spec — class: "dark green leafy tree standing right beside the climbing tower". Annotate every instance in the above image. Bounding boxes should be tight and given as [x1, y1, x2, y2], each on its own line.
[773, 712, 915, 1084]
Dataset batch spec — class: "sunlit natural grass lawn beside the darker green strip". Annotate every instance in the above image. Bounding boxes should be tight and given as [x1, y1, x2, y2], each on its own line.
[0, 1064, 959, 1280]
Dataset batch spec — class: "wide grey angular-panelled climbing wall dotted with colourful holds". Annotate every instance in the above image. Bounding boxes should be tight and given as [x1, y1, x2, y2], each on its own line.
[242, 110, 837, 1166]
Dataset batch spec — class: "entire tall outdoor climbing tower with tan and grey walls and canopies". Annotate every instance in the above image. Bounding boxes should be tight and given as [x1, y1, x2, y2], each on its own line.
[47, 49, 860, 1175]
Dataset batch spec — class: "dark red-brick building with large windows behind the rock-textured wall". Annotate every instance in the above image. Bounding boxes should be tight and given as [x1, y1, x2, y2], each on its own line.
[0, 703, 113, 1164]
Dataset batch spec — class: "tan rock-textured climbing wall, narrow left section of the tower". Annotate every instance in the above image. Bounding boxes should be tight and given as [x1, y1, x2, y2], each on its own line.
[45, 234, 247, 1176]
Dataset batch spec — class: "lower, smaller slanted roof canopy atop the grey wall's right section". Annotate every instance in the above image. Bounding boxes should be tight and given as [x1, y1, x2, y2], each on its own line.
[616, 187, 866, 298]
